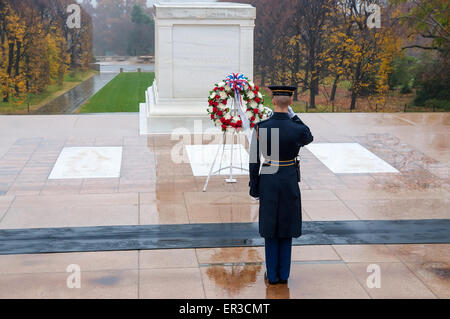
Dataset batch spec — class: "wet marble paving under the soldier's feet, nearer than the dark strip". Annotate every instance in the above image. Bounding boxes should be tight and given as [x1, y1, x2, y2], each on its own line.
[0, 245, 450, 299]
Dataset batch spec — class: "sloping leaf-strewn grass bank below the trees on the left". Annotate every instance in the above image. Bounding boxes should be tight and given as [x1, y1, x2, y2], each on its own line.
[0, 70, 97, 114]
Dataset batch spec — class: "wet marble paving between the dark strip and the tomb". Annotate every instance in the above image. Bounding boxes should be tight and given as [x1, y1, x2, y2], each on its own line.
[0, 114, 450, 227]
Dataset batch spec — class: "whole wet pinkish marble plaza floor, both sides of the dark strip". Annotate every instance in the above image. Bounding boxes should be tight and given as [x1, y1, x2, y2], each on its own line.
[0, 113, 450, 298]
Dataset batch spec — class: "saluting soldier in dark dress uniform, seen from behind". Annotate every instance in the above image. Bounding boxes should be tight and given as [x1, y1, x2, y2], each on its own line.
[249, 86, 313, 284]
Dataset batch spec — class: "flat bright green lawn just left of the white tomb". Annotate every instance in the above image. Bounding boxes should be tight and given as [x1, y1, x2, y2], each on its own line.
[77, 72, 155, 113]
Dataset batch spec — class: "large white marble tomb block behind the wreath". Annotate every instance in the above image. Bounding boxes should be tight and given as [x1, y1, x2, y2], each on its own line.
[140, 2, 256, 134]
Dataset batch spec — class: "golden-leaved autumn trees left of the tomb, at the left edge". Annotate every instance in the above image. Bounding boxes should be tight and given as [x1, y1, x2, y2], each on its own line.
[0, 0, 93, 103]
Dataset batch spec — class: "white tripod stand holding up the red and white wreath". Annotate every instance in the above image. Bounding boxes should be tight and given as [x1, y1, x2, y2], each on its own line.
[203, 96, 249, 192]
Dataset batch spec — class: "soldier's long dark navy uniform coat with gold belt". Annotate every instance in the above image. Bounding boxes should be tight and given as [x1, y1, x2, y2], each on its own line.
[249, 112, 313, 238]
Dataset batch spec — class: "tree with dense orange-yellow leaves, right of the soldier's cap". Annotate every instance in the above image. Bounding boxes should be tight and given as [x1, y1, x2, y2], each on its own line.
[323, 0, 400, 110]
